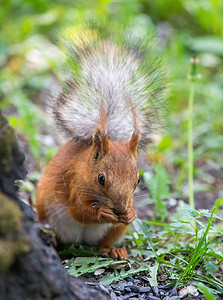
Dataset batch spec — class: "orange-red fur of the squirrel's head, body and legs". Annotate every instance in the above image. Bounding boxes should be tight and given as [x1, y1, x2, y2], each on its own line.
[36, 132, 138, 258]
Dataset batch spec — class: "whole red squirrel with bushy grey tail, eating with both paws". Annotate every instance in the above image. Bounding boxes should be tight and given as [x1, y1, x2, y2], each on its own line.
[36, 31, 166, 259]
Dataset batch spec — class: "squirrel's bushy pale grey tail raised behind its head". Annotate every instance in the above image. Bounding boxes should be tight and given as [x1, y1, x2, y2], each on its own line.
[52, 27, 168, 148]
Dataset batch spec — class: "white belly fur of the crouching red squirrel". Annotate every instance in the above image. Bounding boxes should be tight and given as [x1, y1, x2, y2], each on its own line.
[49, 205, 113, 245]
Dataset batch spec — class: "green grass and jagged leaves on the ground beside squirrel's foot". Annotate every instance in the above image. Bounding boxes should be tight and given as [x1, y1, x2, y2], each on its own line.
[61, 199, 223, 295]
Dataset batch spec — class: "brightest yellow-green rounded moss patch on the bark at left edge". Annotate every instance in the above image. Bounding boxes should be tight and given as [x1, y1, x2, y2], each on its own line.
[0, 193, 22, 238]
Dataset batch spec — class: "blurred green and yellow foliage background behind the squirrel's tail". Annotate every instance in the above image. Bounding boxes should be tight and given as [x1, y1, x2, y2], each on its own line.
[0, 0, 223, 193]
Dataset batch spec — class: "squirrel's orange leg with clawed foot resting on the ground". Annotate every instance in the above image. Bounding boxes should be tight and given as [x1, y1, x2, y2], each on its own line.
[99, 224, 128, 259]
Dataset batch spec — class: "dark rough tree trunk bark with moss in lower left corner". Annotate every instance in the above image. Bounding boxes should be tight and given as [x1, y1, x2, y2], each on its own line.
[0, 111, 110, 300]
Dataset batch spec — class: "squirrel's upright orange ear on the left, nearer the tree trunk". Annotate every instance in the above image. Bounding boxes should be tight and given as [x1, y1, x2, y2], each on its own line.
[93, 130, 109, 159]
